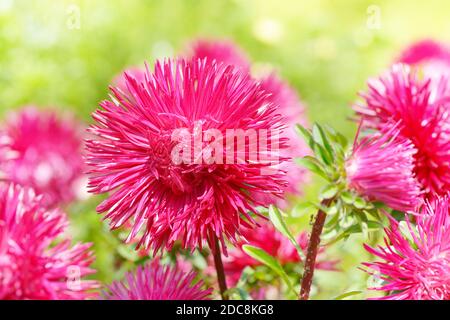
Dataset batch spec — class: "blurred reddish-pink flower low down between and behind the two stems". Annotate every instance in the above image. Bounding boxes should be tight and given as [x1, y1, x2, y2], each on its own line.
[218, 220, 338, 286]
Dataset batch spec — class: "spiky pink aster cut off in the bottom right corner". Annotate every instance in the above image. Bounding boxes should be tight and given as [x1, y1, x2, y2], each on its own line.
[364, 198, 450, 300]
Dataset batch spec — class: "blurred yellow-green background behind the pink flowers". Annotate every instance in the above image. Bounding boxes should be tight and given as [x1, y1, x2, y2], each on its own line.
[0, 0, 450, 299]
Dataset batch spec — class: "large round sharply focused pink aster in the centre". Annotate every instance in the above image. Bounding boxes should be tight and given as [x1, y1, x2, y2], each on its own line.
[87, 59, 286, 255]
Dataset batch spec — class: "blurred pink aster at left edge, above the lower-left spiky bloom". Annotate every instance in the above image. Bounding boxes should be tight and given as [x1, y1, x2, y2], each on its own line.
[0, 107, 83, 206]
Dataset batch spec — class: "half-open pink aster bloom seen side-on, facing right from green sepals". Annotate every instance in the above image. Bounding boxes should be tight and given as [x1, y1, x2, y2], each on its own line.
[345, 125, 421, 212]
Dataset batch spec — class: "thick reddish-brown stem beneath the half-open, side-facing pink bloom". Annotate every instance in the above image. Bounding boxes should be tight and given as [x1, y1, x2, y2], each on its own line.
[299, 199, 333, 300]
